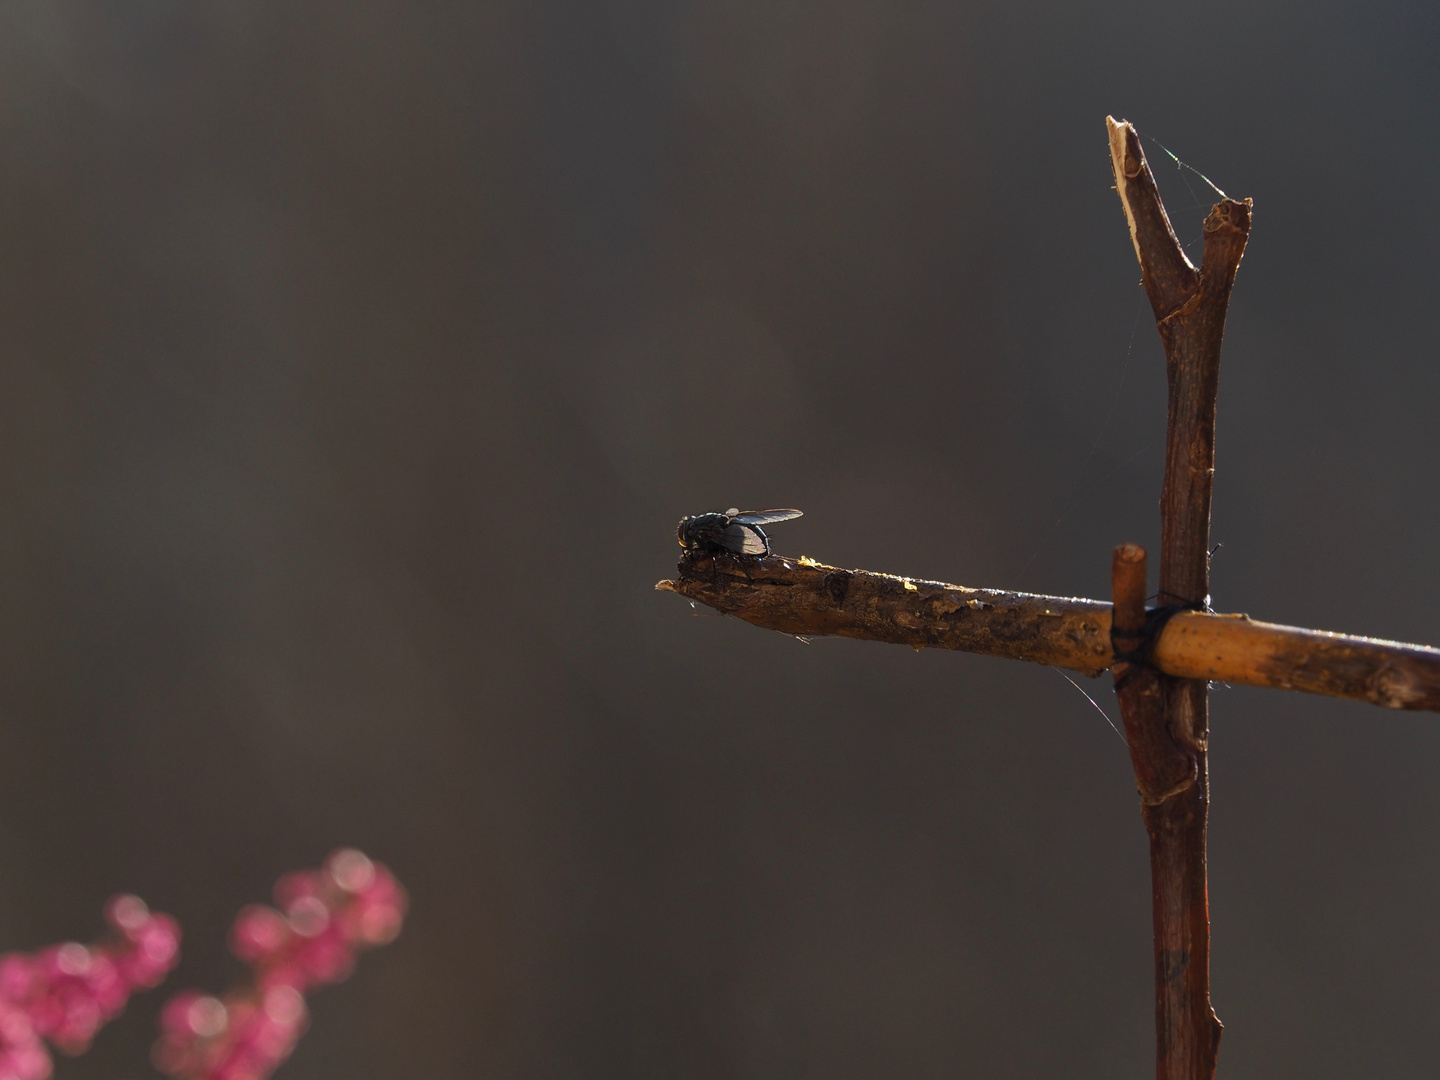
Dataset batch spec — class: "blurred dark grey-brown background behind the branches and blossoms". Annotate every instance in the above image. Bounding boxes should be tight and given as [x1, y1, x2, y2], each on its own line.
[0, 0, 1440, 1080]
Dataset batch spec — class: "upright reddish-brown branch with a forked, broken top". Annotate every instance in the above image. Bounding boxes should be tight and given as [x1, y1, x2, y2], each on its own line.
[1106, 118, 1250, 1080]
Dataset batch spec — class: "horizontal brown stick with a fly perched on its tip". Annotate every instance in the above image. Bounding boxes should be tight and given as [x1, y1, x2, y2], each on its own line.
[655, 554, 1440, 711]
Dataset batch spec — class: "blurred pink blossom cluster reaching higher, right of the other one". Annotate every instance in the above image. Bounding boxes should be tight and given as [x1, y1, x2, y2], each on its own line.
[153, 848, 406, 1080]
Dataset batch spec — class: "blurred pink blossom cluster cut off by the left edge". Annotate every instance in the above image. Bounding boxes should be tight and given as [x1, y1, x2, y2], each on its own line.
[0, 896, 180, 1080]
